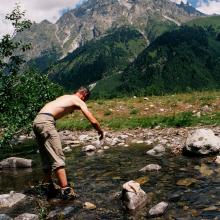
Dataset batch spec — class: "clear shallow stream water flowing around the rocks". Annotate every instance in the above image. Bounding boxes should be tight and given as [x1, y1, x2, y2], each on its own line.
[0, 145, 220, 220]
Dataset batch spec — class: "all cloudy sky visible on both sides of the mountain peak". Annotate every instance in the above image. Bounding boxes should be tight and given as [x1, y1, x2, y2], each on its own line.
[0, 0, 220, 37]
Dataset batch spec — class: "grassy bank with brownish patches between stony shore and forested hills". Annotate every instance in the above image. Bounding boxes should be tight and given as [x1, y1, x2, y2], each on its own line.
[57, 92, 220, 130]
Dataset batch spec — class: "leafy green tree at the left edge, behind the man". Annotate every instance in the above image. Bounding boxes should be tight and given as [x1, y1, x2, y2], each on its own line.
[0, 5, 62, 146]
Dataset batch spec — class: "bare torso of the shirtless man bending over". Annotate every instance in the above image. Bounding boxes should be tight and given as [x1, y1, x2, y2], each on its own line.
[39, 95, 86, 119]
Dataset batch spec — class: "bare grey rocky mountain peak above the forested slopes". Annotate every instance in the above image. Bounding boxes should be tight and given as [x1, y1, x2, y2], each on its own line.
[17, 0, 205, 64]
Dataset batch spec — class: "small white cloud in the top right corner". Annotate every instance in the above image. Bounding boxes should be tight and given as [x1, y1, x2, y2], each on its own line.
[196, 0, 220, 15]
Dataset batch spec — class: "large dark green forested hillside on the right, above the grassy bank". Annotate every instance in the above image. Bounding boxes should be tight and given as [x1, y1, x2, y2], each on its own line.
[114, 26, 220, 95]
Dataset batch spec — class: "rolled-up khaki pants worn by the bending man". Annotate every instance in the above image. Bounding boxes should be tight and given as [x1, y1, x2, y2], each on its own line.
[33, 114, 65, 171]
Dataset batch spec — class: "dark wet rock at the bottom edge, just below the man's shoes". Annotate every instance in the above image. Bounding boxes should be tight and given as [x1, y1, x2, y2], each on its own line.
[47, 206, 74, 220]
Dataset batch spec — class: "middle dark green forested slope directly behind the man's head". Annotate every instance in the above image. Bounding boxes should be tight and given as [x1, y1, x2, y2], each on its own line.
[49, 27, 147, 90]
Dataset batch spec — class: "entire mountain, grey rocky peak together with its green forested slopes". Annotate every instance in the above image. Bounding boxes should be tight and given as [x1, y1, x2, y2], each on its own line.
[17, 0, 220, 98]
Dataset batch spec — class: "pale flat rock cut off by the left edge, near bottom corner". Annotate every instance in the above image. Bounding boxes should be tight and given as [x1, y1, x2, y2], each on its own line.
[0, 191, 26, 208]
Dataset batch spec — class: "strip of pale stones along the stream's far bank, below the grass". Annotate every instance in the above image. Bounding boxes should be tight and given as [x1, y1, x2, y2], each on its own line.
[60, 126, 220, 154]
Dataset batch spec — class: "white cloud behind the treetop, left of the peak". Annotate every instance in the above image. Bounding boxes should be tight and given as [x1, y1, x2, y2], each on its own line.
[0, 0, 82, 37]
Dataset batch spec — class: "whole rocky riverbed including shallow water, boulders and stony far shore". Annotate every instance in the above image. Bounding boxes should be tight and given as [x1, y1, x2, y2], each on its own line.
[0, 127, 220, 219]
